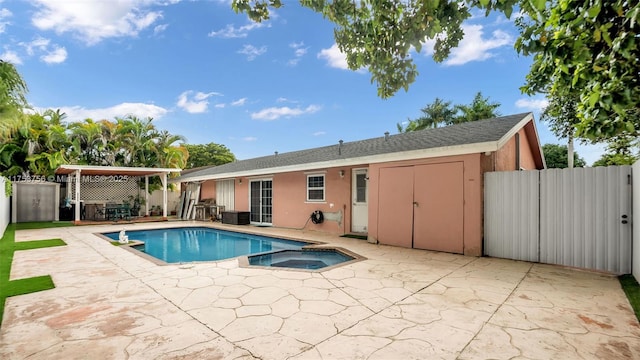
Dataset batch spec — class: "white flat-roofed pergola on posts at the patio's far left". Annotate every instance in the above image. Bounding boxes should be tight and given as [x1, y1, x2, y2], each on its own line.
[56, 165, 182, 223]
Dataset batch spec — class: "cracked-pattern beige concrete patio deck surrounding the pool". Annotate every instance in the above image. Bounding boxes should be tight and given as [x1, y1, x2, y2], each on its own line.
[0, 222, 640, 359]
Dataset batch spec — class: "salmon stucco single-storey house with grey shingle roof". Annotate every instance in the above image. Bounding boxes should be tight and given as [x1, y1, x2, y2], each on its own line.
[174, 113, 545, 256]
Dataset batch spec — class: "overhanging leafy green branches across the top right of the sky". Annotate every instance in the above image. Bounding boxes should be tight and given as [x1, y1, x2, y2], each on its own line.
[232, 0, 640, 140]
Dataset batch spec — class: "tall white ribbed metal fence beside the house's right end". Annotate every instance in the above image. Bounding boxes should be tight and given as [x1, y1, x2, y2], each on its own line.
[484, 166, 632, 274]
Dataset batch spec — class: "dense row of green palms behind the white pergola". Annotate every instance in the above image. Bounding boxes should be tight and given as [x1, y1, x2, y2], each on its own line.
[0, 110, 189, 175]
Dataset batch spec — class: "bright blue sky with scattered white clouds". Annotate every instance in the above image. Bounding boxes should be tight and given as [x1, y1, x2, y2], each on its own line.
[0, 0, 602, 164]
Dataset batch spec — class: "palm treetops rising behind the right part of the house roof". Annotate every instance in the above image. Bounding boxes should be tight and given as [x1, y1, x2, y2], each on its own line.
[396, 92, 500, 133]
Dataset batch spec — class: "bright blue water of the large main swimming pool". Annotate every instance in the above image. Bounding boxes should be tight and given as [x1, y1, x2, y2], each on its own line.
[102, 227, 309, 263]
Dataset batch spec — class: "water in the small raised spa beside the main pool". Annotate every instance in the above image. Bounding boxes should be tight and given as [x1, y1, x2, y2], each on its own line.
[249, 249, 354, 269]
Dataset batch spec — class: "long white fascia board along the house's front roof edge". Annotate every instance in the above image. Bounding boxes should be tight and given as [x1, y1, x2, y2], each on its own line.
[173, 141, 499, 182]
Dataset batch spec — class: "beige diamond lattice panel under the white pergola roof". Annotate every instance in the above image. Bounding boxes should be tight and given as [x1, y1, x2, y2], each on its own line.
[70, 175, 144, 203]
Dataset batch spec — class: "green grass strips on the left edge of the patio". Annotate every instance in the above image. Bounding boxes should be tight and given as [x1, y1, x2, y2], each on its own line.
[0, 223, 68, 324]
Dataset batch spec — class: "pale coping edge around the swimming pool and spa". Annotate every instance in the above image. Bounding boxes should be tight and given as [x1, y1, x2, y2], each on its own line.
[93, 224, 367, 273]
